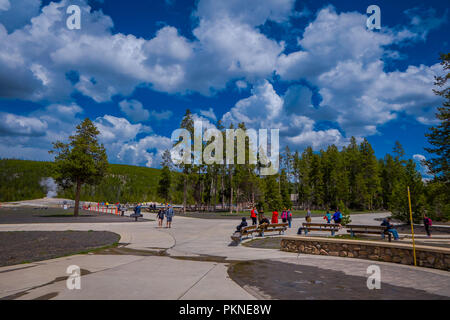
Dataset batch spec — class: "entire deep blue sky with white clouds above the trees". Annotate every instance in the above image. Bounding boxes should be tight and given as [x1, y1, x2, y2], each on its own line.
[0, 0, 450, 178]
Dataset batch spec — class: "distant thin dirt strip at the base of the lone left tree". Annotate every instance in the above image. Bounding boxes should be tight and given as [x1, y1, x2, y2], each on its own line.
[0, 207, 152, 224]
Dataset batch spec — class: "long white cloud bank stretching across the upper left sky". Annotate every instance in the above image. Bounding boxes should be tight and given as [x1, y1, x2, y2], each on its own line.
[0, 0, 293, 102]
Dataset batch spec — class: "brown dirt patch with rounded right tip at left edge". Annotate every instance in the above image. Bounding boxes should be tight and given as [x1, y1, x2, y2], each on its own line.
[0, 231, 120, 266]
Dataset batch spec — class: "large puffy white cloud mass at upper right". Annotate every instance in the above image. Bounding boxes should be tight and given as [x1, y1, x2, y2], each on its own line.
[277, 7, 441, 136]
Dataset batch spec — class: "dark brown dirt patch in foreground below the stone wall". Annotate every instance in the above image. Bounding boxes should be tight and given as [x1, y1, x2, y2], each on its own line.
[228, 260, 449, 300]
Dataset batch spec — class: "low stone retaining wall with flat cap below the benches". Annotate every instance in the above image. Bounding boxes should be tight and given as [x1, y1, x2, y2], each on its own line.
[281, 236, 450, 271]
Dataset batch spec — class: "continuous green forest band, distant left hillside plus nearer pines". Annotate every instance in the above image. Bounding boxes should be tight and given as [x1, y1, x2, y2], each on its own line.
[0, 138, 450, 220]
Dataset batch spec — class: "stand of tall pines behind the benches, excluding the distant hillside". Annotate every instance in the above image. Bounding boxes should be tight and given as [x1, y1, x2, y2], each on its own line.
[159, 110, 450, 221]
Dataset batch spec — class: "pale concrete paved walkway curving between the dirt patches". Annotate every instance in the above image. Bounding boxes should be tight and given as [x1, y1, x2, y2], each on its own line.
[0, 213, 450, 300]
